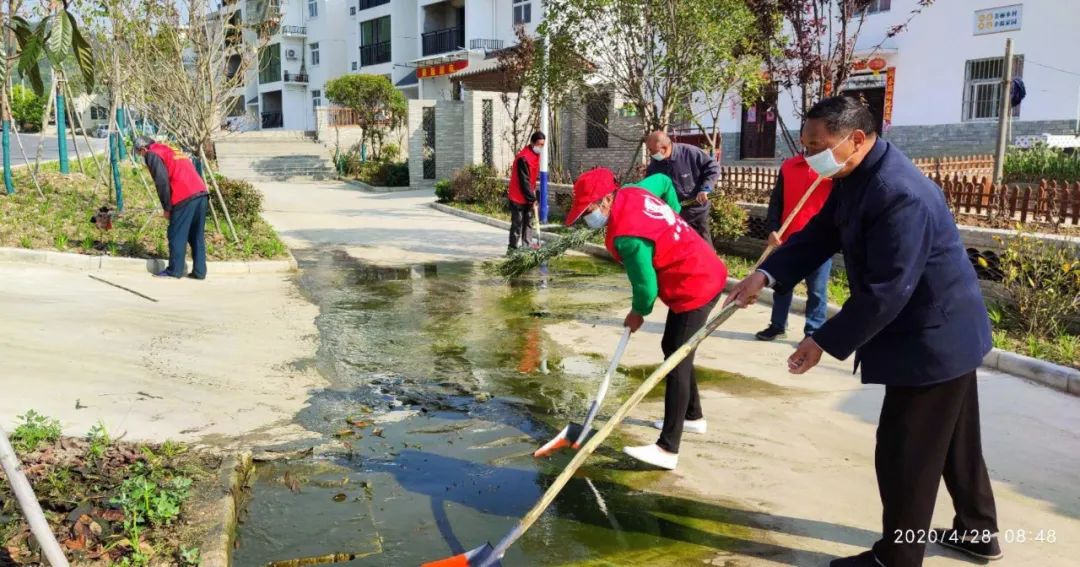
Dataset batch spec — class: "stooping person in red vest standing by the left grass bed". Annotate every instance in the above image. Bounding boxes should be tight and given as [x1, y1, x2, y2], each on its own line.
[135, 136, 210, 280]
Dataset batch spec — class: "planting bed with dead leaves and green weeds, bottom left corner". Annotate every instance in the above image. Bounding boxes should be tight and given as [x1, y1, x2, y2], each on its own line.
[0, 411, 220, 566]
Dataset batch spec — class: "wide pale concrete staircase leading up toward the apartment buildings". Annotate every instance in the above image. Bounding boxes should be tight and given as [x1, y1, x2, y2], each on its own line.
[215, 131, 337, 181]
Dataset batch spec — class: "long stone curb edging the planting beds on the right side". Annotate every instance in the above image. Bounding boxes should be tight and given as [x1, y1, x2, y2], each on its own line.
[431, 203, 1080, 395]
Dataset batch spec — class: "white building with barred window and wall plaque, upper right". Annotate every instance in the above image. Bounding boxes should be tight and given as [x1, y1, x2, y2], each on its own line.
[708, 0, 1080, 161]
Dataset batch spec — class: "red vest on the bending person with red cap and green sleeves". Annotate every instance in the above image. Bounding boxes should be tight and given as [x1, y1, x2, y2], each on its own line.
[607, 187, 728, 313]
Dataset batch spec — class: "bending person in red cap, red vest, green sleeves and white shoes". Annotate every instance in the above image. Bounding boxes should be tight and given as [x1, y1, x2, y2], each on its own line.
[566, 167, 728, 470]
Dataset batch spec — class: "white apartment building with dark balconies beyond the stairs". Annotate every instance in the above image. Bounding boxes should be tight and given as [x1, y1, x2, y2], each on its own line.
[219, 0, 542, 131]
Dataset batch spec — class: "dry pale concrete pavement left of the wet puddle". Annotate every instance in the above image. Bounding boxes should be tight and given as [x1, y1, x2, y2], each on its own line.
[0, 264, 324, 445]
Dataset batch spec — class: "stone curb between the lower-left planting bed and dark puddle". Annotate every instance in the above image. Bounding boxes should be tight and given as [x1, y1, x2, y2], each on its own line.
[199, 451, 253, 567]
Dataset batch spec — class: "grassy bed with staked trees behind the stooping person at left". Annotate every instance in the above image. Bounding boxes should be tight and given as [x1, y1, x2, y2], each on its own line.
[0, 158, 287, 260]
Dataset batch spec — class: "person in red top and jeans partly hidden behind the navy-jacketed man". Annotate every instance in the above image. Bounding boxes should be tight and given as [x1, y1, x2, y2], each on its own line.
[754, 154, 833, 340]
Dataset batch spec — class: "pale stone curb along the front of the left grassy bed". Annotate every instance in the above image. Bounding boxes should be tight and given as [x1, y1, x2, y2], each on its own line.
[0, 247, 297, 275]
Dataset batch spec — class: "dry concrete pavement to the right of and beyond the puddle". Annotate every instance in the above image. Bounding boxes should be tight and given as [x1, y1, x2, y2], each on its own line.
[260, 184, 1080, 566]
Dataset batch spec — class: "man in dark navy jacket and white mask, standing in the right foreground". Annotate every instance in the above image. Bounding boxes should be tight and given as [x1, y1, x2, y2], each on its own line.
[727, 97, 1001, 567]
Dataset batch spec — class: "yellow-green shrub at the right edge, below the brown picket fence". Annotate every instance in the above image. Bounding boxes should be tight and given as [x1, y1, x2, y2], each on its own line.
[1000, 233, 1080, 338]
